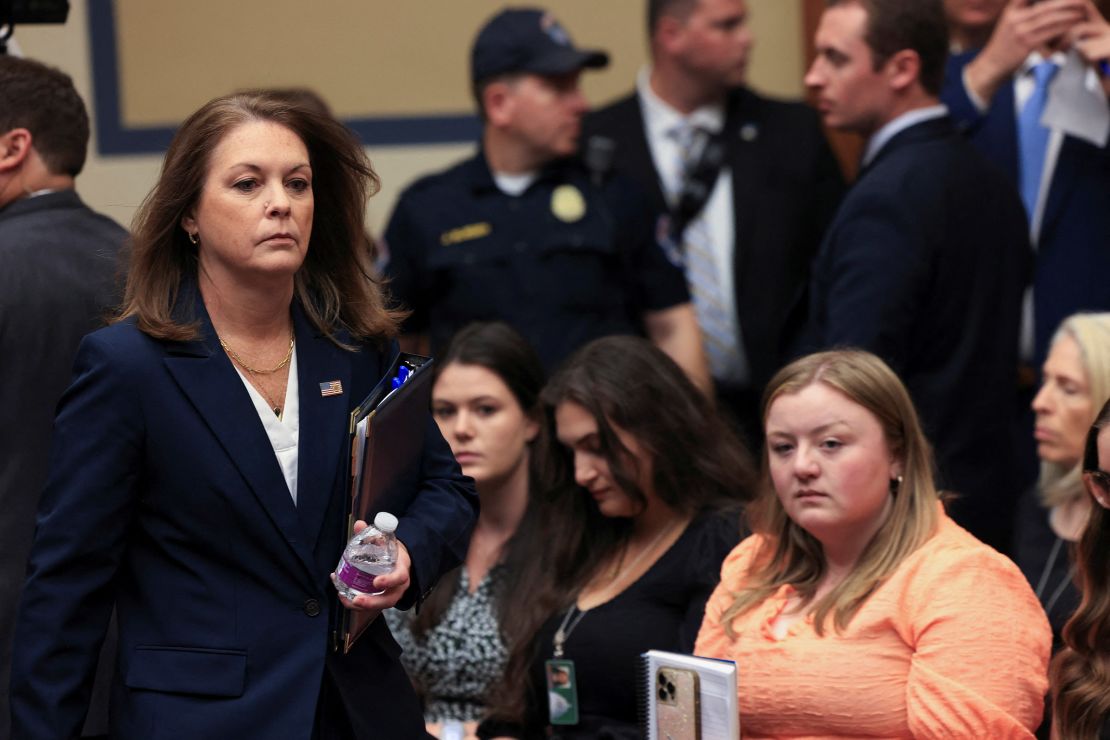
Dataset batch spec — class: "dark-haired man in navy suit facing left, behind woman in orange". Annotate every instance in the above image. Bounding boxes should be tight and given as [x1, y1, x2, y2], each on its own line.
[806, 0, 1029, 548]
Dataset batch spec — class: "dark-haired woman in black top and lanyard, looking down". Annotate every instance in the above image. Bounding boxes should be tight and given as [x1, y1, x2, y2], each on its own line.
[482, 336, 755, 738]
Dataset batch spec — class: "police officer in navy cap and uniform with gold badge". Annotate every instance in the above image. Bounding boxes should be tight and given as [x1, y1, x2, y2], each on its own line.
[385, 9, 710, 389]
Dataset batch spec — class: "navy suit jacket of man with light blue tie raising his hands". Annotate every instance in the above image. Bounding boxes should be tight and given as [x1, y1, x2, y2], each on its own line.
[941, 51, 1110, 367]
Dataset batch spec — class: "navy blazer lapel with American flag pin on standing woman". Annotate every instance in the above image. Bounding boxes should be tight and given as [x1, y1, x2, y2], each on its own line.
[293, 304, 360, 549]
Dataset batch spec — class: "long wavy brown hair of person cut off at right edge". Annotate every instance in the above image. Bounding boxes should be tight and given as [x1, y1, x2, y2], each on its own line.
[1049, 401, 1110, 740]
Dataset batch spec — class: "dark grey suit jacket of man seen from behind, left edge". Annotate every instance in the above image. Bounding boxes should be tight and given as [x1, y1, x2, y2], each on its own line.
[0, 190, 128, 739]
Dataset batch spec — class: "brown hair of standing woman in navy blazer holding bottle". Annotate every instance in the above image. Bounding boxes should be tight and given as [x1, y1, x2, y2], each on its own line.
[120, 90, 402, 341]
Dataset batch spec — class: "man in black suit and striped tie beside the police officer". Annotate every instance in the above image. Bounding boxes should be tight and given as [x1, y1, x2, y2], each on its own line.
[584, 0, 844, 433]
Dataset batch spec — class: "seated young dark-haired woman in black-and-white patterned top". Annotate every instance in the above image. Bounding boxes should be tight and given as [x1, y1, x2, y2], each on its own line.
[385, 322, 544, 734]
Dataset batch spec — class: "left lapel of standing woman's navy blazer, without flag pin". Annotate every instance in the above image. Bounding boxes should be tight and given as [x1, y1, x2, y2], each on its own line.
[164, 292, 317, 587]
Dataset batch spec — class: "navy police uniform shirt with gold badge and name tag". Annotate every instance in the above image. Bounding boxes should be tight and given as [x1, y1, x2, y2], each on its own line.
[385, 153, 689, 371]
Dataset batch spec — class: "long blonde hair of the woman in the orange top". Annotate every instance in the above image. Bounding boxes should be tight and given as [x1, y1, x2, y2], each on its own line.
[720, 349, 939, 639]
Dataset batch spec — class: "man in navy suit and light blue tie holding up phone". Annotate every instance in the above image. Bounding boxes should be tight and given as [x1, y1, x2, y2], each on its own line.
[941, 0, 1110, 375]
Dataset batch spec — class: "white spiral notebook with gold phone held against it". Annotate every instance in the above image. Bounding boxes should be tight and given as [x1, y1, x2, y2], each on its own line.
[639, 650, 740, 740]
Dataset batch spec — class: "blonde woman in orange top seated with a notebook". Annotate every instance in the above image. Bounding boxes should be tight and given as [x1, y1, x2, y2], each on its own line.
[694, 351, 1051, 740]
